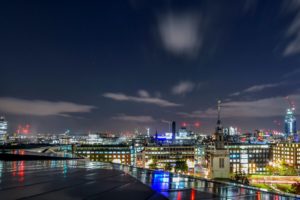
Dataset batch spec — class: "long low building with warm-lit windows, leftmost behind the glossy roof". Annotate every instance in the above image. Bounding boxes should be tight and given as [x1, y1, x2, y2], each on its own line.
[73, 145, 135, 165]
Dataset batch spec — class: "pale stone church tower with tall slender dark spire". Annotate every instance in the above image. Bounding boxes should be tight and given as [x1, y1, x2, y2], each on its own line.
[207, 100, 230, 178]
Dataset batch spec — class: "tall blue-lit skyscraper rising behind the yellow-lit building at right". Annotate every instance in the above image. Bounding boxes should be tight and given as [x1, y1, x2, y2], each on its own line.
[284, 108, 297, 139]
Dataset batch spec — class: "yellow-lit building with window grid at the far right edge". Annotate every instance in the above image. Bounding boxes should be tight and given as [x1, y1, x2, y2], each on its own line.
[272, 143, 300, 169]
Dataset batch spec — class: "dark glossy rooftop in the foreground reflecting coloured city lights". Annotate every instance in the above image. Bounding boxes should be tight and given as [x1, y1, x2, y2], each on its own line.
[0, 160, 295, 200]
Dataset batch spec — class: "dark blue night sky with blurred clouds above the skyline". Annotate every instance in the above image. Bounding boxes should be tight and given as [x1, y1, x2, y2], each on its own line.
[0, 0, 300, 133]
